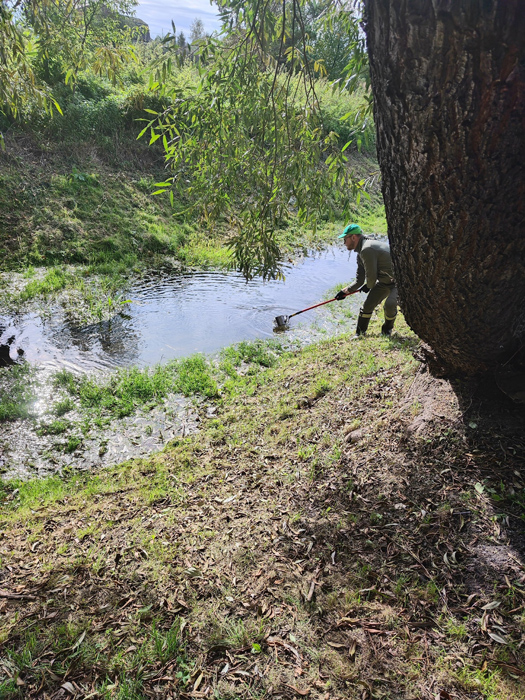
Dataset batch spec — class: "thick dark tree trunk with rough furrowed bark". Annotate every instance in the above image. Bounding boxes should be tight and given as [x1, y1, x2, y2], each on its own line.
[365, 0, 525, 374]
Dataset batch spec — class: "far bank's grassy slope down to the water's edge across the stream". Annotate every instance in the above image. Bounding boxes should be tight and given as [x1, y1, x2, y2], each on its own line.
[0, 133, 386, 314]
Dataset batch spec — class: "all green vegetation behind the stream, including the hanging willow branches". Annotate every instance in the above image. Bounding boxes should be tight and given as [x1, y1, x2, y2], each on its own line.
[0, 0, 380, 286]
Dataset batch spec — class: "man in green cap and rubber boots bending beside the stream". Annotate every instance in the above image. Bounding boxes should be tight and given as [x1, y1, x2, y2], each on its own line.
[335, 224, 397, 335]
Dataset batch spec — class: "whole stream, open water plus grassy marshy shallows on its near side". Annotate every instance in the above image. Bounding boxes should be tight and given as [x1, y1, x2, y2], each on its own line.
[0, 246, 359, 479]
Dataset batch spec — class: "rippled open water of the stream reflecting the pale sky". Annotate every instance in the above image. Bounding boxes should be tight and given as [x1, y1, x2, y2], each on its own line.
[0, 246, 355, 372]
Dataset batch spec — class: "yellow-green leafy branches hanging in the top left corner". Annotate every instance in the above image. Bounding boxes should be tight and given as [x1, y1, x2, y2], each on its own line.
[0, 0, 137, 119]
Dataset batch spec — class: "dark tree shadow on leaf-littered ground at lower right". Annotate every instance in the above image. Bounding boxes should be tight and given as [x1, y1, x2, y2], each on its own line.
[272, 366, 525, 700]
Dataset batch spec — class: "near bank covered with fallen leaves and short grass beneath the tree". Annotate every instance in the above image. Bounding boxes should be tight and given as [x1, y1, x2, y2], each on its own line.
[0, 319, 525, 700]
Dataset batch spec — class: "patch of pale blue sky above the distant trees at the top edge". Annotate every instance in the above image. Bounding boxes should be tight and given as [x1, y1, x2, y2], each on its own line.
[135, 0, 220, 39]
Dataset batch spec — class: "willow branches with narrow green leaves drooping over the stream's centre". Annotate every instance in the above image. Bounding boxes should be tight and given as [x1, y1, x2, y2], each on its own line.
[141, 0, 366, 278]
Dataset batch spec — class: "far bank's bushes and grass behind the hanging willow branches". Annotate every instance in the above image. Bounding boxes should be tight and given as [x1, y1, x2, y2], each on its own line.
[0, 23, 376, 296]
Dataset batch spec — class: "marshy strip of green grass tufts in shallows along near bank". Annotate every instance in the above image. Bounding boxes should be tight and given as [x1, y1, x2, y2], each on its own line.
[0, 340, 287, 464]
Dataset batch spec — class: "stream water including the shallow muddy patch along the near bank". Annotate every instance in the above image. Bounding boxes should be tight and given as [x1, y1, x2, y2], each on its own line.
[0, 246, 359, 479]
